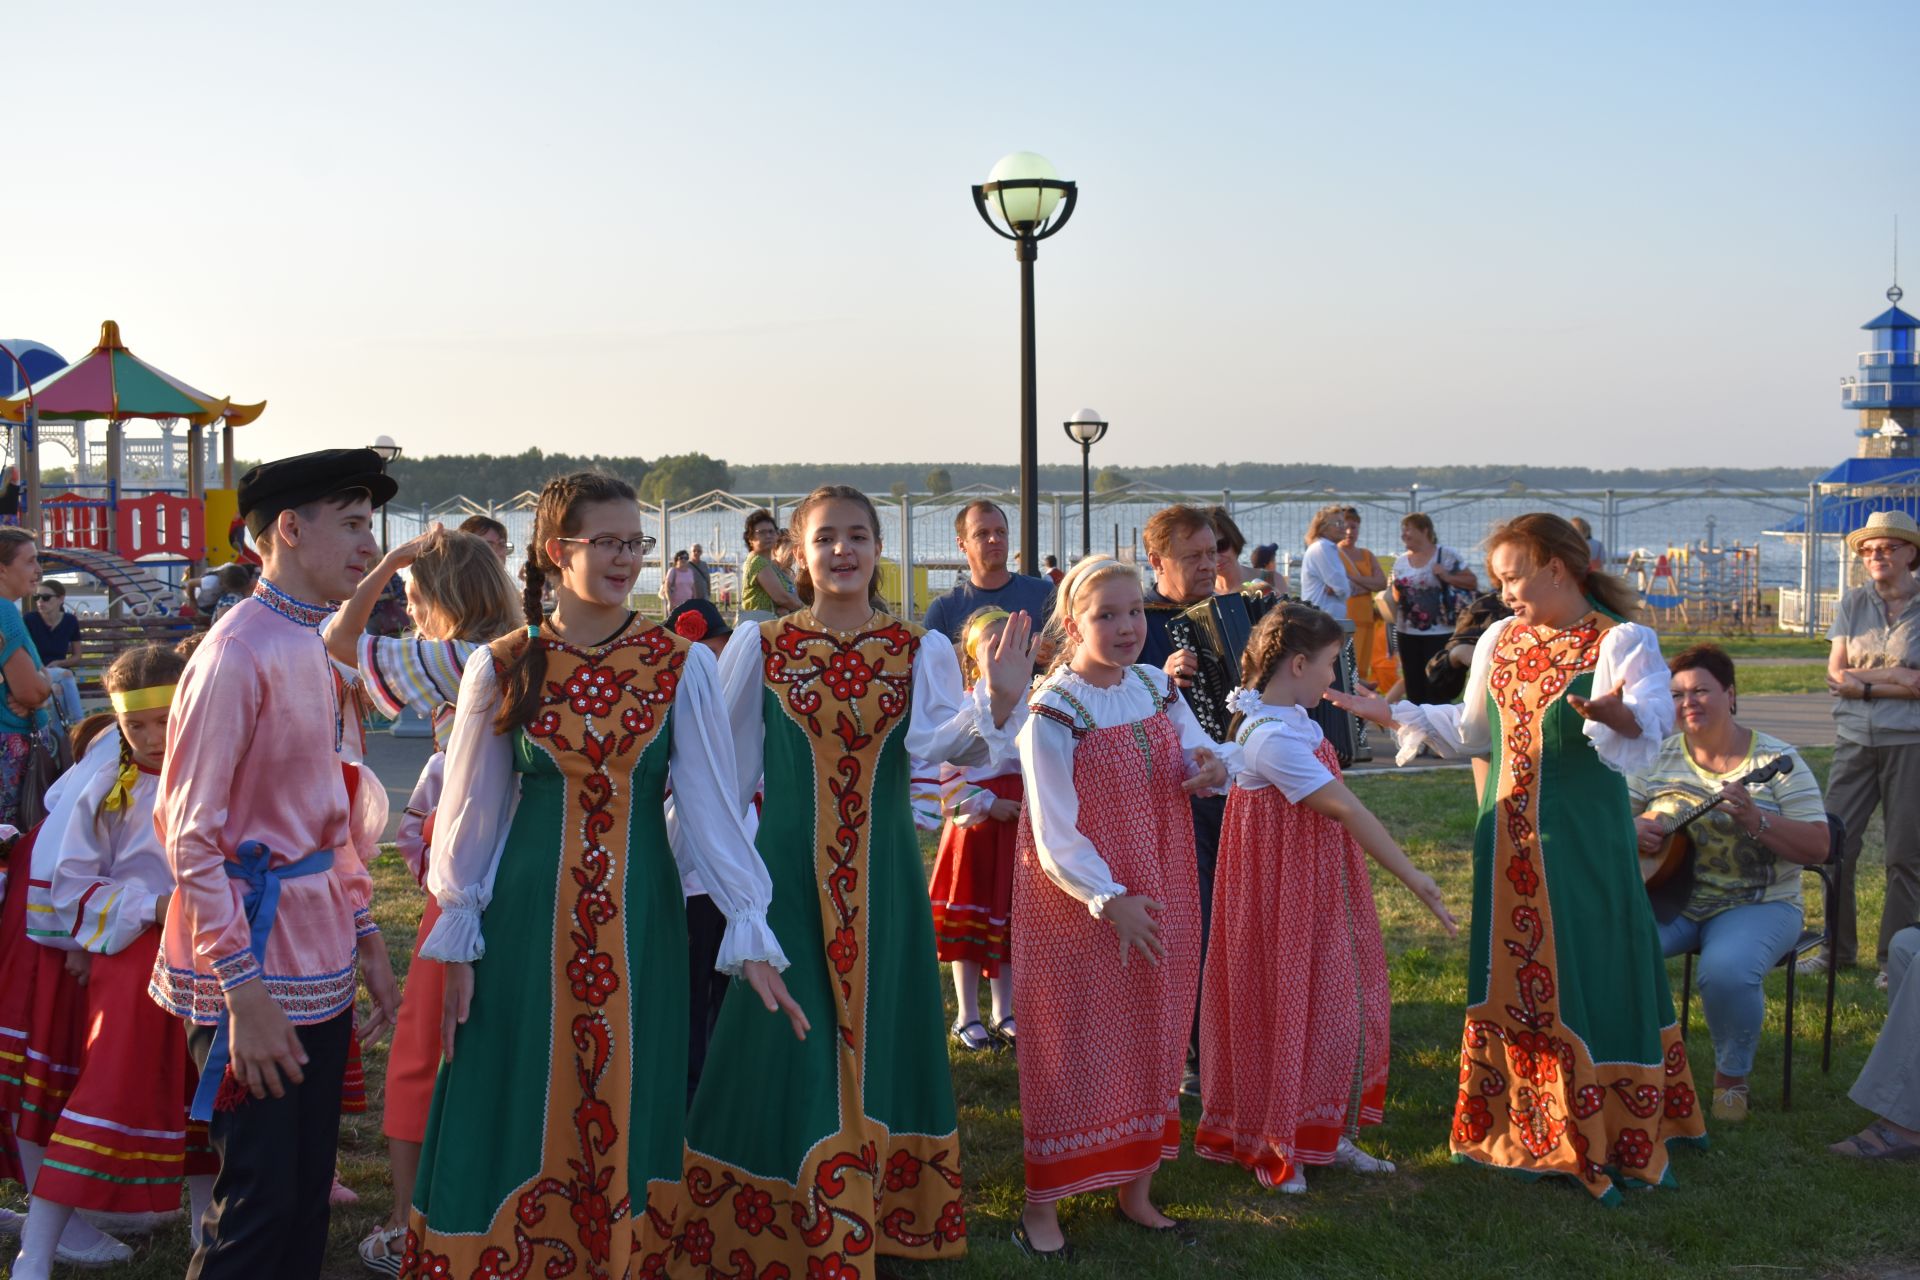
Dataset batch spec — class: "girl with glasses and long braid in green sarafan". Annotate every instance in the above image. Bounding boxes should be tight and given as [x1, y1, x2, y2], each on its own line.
[401, 472, 806, 1280]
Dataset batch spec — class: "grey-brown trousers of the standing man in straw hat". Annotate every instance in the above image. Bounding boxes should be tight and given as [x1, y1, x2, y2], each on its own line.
[1826, 739, 1920, 965]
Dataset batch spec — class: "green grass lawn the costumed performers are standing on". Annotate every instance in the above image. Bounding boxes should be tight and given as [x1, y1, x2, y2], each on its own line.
[11, 750, 1920, 1280]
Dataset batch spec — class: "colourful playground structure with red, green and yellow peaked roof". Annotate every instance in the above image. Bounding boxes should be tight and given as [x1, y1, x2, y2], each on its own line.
[0, 320, 267, 618]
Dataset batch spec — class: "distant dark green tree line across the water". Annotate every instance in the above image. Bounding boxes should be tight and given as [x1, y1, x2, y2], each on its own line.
[362, 449, 1824, 507]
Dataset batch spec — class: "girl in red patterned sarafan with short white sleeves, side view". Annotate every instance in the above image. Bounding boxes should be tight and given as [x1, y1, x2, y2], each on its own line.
[1194, 604, 1455, 1194]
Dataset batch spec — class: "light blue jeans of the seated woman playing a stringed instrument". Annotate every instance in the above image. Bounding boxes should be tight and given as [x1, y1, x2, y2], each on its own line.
[1661, 902, 1801, 1079]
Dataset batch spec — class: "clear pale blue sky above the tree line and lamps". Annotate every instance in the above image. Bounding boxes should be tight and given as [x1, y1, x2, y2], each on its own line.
[0, 0, 1920, 474]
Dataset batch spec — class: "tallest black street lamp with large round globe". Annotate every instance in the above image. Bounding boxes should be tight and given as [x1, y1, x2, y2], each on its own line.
[973, 152, 1079, 574]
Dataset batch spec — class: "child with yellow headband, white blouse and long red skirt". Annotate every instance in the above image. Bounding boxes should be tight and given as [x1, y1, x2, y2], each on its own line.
[13, 645, 217, 1280]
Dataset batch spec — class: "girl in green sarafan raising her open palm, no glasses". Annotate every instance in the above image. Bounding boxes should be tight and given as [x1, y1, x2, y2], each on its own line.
[668, 486, 1033, 1280]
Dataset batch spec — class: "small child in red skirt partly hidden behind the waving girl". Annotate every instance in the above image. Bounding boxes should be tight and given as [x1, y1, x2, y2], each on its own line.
[927, 606, 1025, 1052]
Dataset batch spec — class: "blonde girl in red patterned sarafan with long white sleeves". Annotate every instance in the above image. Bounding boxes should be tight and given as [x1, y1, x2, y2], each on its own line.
[1014, 558, 1236, 1259]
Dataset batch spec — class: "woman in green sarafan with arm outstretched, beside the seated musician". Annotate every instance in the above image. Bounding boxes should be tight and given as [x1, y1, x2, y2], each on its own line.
[1327, 512, 1705, 1203]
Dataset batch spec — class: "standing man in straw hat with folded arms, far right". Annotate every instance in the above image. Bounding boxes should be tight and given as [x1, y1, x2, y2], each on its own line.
[1803, 510, 1920, 986]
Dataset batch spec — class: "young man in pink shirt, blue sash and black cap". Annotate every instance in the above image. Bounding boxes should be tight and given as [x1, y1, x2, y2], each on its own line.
[150, 449, 399, 1280]
